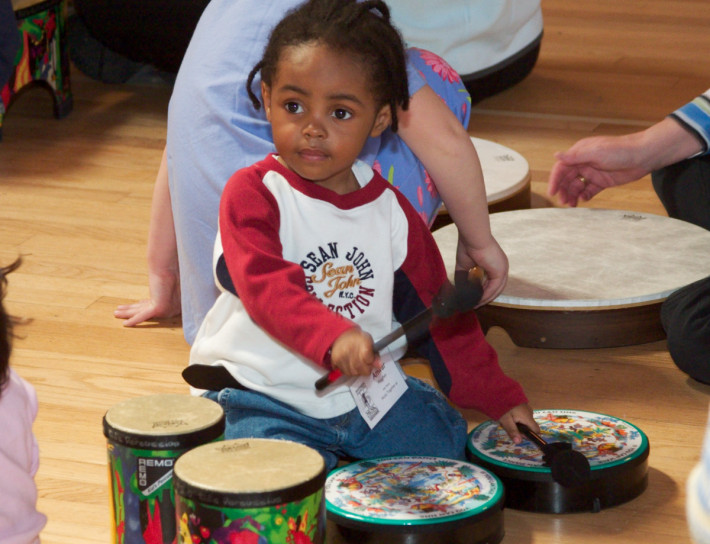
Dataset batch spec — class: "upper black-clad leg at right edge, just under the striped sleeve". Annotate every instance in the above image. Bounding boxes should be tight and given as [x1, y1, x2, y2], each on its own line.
[651, 156, 710, 230]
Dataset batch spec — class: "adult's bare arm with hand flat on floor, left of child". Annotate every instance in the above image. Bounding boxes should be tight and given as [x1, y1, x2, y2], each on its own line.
[114, 147, 180, 327]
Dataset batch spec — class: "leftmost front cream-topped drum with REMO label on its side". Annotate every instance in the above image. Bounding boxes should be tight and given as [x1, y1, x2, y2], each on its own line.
[103, 395, 224, 544]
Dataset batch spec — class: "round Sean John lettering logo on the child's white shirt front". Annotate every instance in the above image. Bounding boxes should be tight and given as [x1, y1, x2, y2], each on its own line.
[300, 242, 375, 319]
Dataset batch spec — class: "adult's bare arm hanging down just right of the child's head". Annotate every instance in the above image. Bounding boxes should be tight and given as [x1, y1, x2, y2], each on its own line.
[397, 86, 508, 304]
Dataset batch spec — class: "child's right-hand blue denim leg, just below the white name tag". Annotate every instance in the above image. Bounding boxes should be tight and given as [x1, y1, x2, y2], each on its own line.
[342, 378, 468, 460]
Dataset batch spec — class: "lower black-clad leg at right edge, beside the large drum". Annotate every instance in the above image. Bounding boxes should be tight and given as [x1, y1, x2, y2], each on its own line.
[661, 277, 710, 384]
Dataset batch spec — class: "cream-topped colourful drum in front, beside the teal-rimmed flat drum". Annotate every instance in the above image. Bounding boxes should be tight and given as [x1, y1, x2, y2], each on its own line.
[175, 438, 326, 544]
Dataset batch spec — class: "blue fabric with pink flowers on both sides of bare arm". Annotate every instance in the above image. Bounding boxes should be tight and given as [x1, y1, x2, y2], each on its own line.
[374, 48, 471, 225]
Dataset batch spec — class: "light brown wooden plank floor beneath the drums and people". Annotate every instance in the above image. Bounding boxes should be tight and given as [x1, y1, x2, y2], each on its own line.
[0, 0, 710, 544]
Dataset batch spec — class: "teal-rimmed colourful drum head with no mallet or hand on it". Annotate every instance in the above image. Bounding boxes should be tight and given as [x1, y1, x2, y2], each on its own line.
[325, 457, 503, 525]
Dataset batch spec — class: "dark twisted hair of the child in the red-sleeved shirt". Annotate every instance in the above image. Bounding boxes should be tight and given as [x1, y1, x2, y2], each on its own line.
[247, 0, 409, 132]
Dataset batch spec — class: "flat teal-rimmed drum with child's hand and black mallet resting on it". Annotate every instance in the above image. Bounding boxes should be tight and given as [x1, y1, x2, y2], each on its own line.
[467, 410, 649, 514]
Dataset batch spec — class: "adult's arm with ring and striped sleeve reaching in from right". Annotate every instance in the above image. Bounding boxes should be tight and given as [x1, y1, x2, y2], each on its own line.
[548, 91, 710, 206]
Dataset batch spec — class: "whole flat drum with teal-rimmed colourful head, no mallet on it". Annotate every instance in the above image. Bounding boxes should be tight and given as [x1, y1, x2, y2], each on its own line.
[325, 457, 504, 544]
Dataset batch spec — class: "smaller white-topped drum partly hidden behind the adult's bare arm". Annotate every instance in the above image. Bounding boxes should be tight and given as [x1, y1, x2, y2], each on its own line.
[433, 138, 530, 229]
